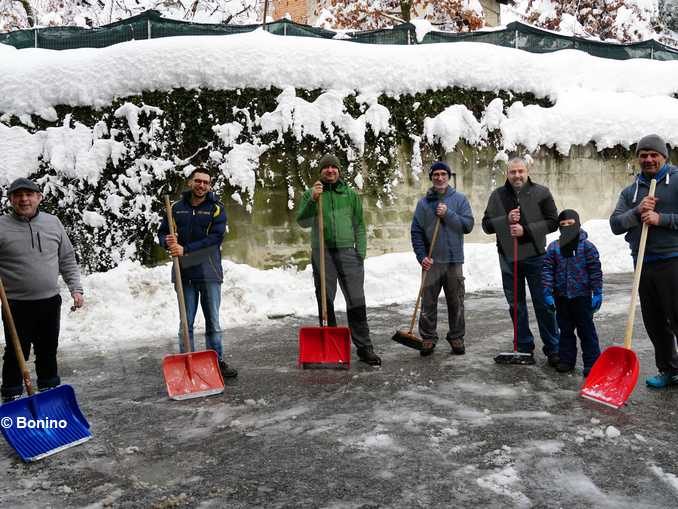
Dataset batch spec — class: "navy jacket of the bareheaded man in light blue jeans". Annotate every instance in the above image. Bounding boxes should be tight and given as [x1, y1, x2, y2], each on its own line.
[158, 191, 226, 283]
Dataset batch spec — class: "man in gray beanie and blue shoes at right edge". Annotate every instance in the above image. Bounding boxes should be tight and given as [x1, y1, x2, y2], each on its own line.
[610, 134, 678, 388]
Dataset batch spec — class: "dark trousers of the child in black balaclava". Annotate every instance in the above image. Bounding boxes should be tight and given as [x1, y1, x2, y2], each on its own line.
[556, 297, 600, 369]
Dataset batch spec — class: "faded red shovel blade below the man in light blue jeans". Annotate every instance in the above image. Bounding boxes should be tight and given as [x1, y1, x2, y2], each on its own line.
[162, 350, 224, 399]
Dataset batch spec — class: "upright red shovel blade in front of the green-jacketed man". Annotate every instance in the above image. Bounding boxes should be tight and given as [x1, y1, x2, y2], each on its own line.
[298, 327, 351, 369]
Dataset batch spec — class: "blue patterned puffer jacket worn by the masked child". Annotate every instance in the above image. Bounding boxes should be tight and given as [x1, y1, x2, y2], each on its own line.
[542, 229, 603, 299]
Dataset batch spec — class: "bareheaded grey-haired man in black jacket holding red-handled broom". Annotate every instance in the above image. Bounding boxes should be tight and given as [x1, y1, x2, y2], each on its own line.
[482, 157, 559, 367]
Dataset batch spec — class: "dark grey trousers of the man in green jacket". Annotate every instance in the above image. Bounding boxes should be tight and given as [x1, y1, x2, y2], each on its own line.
[312, 248, 372, 348]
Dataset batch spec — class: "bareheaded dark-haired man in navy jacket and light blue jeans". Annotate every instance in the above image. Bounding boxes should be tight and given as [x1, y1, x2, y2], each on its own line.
[158, 168, 238, 378]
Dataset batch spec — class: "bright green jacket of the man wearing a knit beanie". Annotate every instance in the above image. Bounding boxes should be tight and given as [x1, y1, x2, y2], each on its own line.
[297, 180, 367, 260]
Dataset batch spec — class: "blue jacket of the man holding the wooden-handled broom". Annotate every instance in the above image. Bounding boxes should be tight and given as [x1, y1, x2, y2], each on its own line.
[410, 187, 473, 263]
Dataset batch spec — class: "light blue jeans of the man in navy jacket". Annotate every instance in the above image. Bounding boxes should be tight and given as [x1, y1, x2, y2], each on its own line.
[179, 281, 224, 360]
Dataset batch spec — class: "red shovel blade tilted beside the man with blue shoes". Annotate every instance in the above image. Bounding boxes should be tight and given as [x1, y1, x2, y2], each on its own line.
[580, 346, 640, 408]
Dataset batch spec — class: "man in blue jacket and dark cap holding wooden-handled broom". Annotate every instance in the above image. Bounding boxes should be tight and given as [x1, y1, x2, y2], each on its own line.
[410, 161, 473, 356]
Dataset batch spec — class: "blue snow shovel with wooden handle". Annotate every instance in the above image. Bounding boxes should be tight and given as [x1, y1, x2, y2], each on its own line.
[0, 280, 92, 462]
